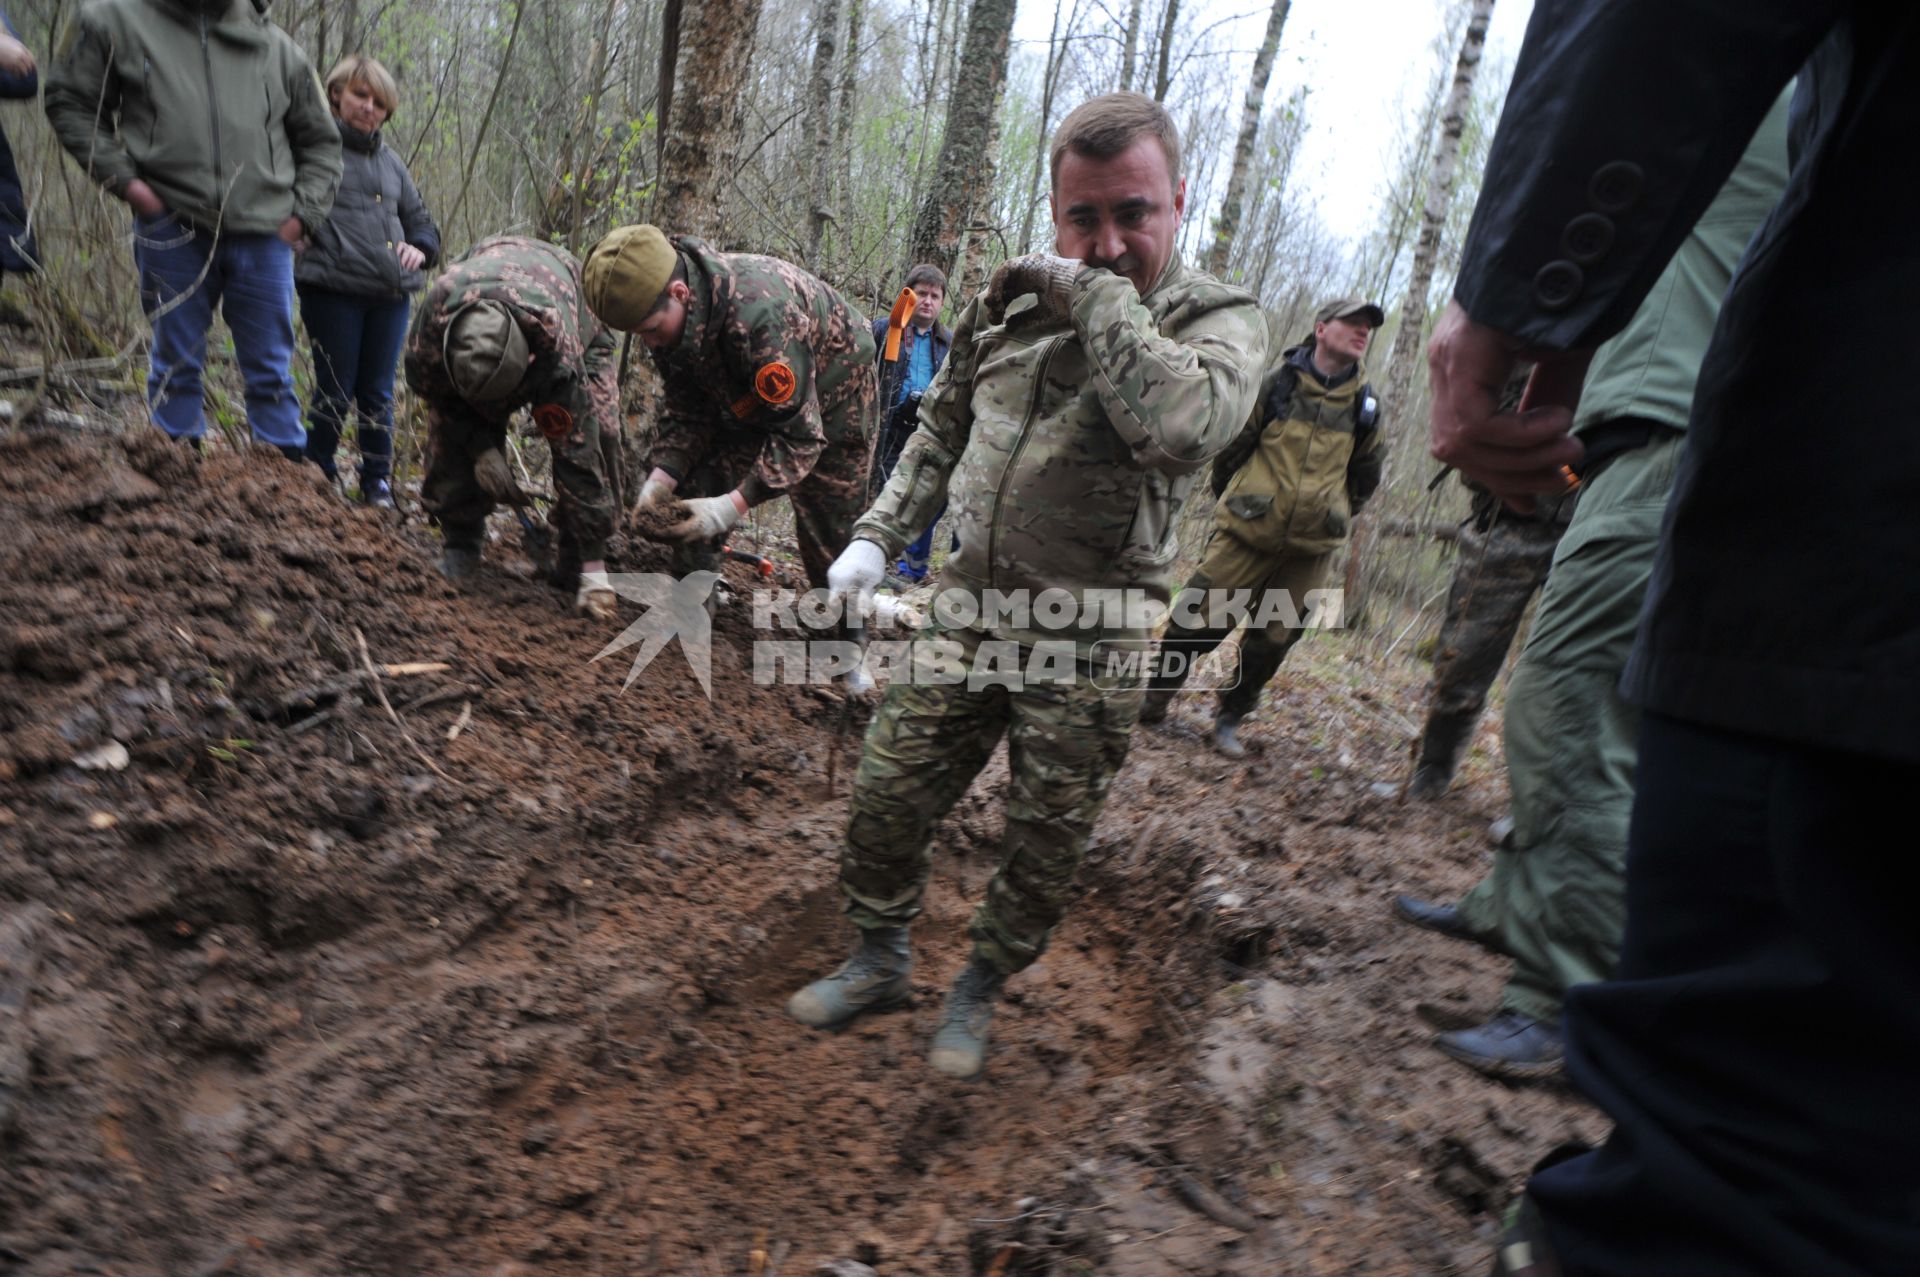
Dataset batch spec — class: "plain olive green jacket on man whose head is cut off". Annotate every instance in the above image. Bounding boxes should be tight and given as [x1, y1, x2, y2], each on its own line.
[46, 0, 340, 234]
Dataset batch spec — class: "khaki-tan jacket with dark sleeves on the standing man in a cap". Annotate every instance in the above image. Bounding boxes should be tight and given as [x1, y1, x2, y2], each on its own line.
[1213, 346, 1386, 553]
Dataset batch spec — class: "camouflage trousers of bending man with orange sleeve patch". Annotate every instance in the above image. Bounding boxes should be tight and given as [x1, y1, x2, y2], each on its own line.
[674, 365, 876, 590]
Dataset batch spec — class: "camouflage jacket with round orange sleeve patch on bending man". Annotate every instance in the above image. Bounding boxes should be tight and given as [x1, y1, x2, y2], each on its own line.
[653, 236, 874, 505]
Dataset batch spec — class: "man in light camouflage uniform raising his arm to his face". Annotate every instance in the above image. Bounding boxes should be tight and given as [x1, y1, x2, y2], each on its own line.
[787, 94, 1265, 1077]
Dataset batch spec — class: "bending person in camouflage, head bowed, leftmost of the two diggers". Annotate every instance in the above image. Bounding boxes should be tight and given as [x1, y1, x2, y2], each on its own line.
[405, 234, 620, 620]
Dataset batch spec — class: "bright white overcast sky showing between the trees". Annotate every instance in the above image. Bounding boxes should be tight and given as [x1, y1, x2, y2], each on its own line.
[1016, 0, 1534, 238]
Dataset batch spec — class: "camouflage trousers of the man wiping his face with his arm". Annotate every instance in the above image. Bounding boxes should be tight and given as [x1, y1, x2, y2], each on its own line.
[839, 626, 1140, 972]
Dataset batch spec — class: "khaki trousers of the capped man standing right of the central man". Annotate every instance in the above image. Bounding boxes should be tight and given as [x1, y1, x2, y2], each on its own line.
[1154, 528, 1332, 716]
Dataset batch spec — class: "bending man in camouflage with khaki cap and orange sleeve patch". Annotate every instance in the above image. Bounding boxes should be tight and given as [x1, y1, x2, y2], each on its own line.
[568, 225, 876, 588]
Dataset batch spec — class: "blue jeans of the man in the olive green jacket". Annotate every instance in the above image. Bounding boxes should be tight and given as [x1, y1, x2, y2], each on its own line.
[132, 213, 307, 451]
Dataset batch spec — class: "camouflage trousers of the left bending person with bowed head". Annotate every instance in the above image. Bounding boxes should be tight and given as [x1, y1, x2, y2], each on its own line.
[420, 401, 624, 561]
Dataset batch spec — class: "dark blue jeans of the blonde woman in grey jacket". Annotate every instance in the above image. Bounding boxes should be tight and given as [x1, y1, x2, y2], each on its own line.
[300, 288, 407, 480]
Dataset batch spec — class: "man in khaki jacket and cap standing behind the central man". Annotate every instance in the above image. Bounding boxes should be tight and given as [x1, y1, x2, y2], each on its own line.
[1140, 298, 1386, 759]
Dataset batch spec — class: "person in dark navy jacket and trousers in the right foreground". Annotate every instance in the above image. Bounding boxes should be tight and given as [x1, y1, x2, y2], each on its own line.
[1428, 0, 1920, 1277]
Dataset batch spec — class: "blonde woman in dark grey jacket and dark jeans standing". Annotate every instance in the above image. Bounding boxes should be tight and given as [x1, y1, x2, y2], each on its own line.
[294, 54, 440, 509]
